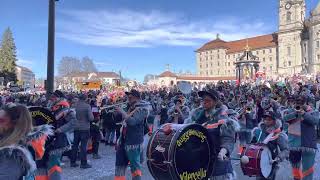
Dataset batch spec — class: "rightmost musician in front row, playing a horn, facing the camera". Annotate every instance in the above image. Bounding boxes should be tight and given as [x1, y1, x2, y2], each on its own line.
[284, 95, 319, 180]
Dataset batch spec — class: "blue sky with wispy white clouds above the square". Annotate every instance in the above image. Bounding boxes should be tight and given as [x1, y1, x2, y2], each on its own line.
[0, 0, 318, 80]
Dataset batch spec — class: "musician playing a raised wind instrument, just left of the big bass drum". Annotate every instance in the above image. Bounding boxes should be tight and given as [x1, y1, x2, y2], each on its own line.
[115, 89, 149, 180]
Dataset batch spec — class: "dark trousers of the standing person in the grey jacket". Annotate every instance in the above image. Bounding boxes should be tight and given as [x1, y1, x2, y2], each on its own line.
[71, 130, 90, 165]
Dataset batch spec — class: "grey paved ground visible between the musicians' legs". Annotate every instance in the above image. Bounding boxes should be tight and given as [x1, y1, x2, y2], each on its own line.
[63, 138, 320, 180]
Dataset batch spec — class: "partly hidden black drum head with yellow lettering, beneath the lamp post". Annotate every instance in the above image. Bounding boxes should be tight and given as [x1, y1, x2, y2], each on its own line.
[29, 106, 55, 126]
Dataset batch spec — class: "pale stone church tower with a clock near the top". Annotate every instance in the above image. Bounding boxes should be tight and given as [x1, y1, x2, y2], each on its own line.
[278, 0, 306, 74]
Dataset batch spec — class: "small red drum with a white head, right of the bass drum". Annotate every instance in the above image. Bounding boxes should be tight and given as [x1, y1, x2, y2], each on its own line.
[241, 144, 272, 178]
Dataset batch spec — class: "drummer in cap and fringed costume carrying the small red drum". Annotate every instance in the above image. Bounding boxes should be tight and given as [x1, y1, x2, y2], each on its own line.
[251, 111, 289, 180]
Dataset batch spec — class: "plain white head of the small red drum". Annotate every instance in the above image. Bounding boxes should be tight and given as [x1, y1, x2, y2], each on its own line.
[260, 147, 272, 178]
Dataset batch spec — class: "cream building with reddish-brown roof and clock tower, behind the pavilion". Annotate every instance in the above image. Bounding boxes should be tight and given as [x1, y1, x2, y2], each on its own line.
[196, 0, 320, 77]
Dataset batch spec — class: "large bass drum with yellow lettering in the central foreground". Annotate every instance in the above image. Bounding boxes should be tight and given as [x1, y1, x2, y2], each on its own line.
[147, 124, 214, 180]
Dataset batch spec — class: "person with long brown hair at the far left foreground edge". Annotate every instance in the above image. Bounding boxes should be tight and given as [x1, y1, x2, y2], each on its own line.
[0, 103, 40, 180]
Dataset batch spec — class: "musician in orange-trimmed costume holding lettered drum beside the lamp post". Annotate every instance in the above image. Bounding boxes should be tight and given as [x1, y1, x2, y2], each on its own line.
[35, 92, 76, 180]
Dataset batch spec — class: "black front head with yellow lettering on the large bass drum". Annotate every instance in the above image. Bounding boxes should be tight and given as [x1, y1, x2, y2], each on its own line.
[172, 124, 213, 179]
